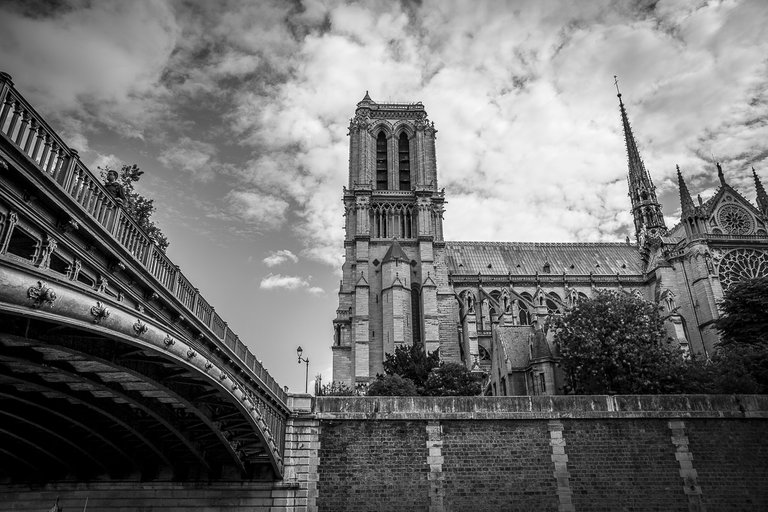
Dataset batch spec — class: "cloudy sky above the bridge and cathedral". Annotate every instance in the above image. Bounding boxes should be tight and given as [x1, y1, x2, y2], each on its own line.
[0, 0, 768, 392]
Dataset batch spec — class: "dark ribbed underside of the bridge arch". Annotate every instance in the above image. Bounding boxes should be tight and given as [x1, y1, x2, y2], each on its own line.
[0, 311, 276, 482]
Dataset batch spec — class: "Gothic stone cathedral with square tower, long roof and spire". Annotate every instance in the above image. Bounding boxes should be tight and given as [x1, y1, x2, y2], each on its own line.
[332, 93, 768, 395]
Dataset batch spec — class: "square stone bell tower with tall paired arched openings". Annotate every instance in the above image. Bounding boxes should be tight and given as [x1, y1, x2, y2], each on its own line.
[333, 92, 452, 385]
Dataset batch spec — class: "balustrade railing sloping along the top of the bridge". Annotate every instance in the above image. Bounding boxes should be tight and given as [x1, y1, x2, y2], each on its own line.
[0, 72, 287, 406]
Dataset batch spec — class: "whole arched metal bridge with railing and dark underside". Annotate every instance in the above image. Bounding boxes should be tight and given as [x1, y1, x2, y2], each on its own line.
[0, 73, 290, 482]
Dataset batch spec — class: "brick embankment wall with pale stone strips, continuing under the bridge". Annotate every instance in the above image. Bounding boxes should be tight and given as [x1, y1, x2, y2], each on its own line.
[0, 395, 768, 512]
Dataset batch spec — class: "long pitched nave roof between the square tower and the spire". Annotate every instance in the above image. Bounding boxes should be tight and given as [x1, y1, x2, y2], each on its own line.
[445, 242, 643, 276]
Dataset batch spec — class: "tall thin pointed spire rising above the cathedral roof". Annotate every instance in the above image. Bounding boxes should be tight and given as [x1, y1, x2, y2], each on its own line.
[613, 75, 667, 244]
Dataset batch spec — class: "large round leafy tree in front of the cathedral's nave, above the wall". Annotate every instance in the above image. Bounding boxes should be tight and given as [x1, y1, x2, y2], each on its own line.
[555, 291, 683, 394]
